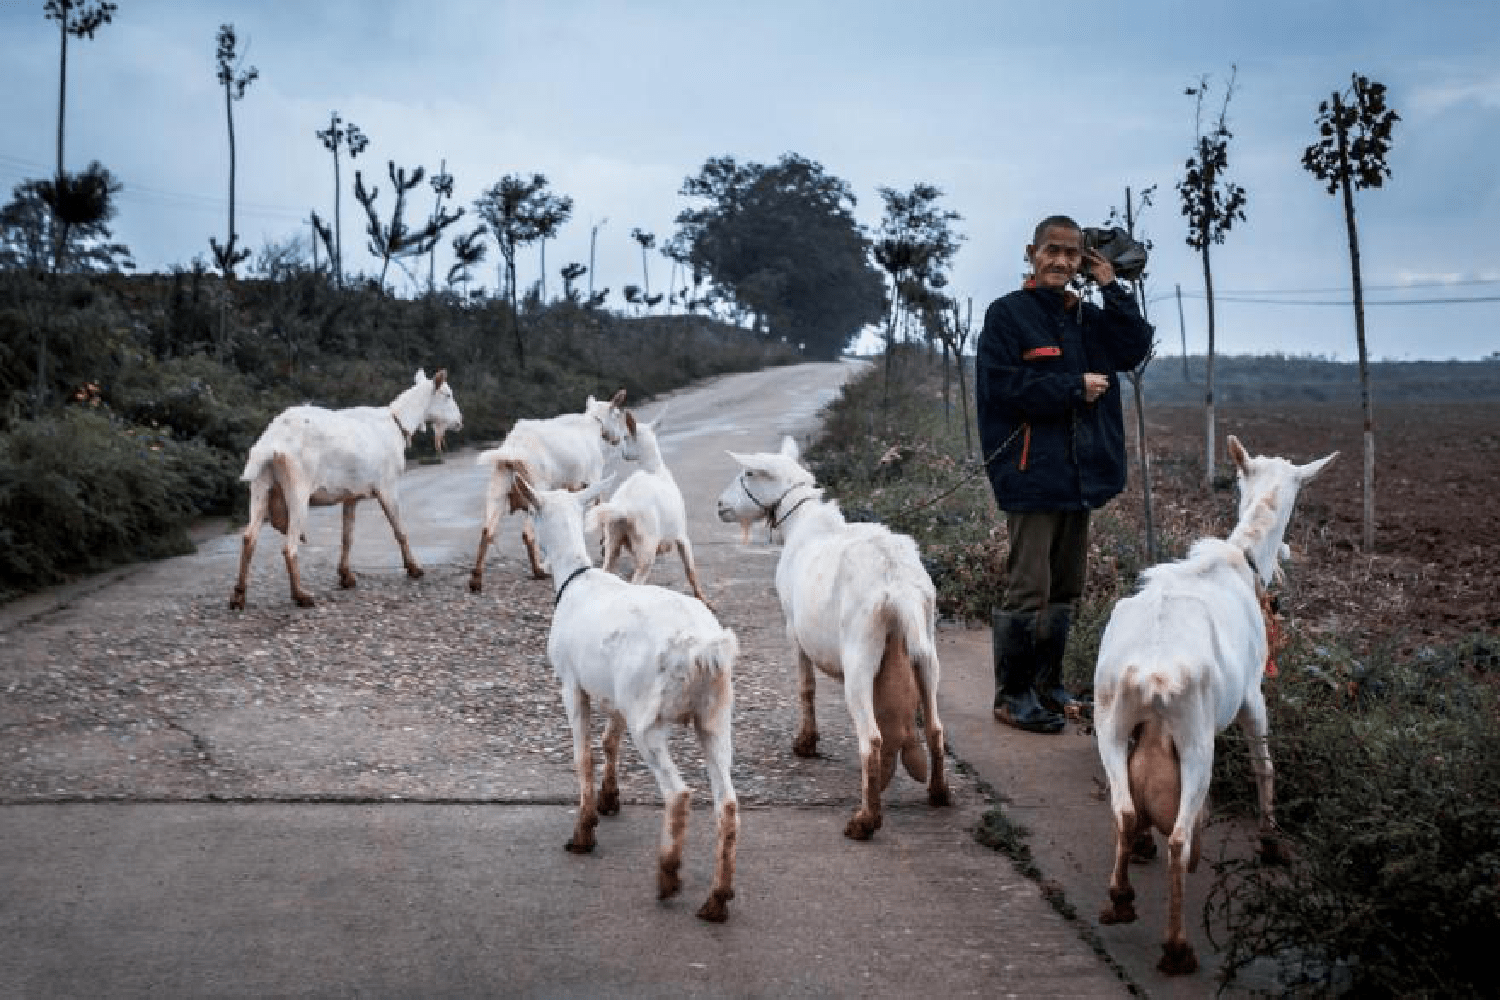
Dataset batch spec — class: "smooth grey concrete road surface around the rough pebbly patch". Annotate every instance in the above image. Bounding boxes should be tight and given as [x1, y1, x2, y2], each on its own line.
[0, 364, 1134, 997]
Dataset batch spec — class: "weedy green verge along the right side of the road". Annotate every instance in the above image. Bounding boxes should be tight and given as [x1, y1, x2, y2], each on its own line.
[807, 351, 1500, 997]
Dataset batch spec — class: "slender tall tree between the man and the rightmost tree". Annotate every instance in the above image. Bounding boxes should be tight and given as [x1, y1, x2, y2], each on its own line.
[1178, 72, 1245, 490]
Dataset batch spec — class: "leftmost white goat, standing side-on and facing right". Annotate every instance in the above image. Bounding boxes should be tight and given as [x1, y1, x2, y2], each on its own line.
[230, 369, 464, 610]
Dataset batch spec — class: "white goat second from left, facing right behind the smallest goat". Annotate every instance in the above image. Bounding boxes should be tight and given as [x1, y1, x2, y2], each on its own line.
[470, 390, 629, 594]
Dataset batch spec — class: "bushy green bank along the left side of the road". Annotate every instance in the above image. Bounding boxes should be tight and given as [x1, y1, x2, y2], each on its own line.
[0, 265, 801, 600]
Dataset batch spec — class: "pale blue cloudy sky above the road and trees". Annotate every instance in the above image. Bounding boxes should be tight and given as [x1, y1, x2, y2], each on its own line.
[0, 0, 1500, 361]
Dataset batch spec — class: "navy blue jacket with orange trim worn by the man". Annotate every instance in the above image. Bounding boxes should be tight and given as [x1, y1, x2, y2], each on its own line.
[975, 283, 1152, 513]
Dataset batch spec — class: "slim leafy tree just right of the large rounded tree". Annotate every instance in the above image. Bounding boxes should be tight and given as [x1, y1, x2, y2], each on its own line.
[875, 181, 963, 394]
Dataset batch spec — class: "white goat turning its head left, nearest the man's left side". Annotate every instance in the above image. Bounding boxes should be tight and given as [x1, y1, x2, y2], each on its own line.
[719, 438, 948, 840]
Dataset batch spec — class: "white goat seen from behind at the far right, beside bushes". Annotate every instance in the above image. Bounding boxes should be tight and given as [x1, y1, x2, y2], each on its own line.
[1094, 436, 1338, 975]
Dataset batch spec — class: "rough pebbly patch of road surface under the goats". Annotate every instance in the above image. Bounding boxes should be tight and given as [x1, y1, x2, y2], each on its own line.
[0, 546, 965, 808]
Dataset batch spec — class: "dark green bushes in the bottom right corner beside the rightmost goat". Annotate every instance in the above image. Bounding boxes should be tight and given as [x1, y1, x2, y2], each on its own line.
[1211, 639, 1500, 997]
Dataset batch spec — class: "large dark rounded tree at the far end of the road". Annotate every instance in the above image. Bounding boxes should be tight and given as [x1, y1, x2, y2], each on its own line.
[677, 153, 885, 358]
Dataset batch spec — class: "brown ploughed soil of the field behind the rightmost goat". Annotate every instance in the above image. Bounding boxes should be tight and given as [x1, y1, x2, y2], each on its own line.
[1119, 402, 1500, 652]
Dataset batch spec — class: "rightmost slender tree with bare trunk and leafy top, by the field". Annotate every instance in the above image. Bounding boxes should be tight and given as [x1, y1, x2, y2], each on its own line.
[1302, 73, 1401, 552]
